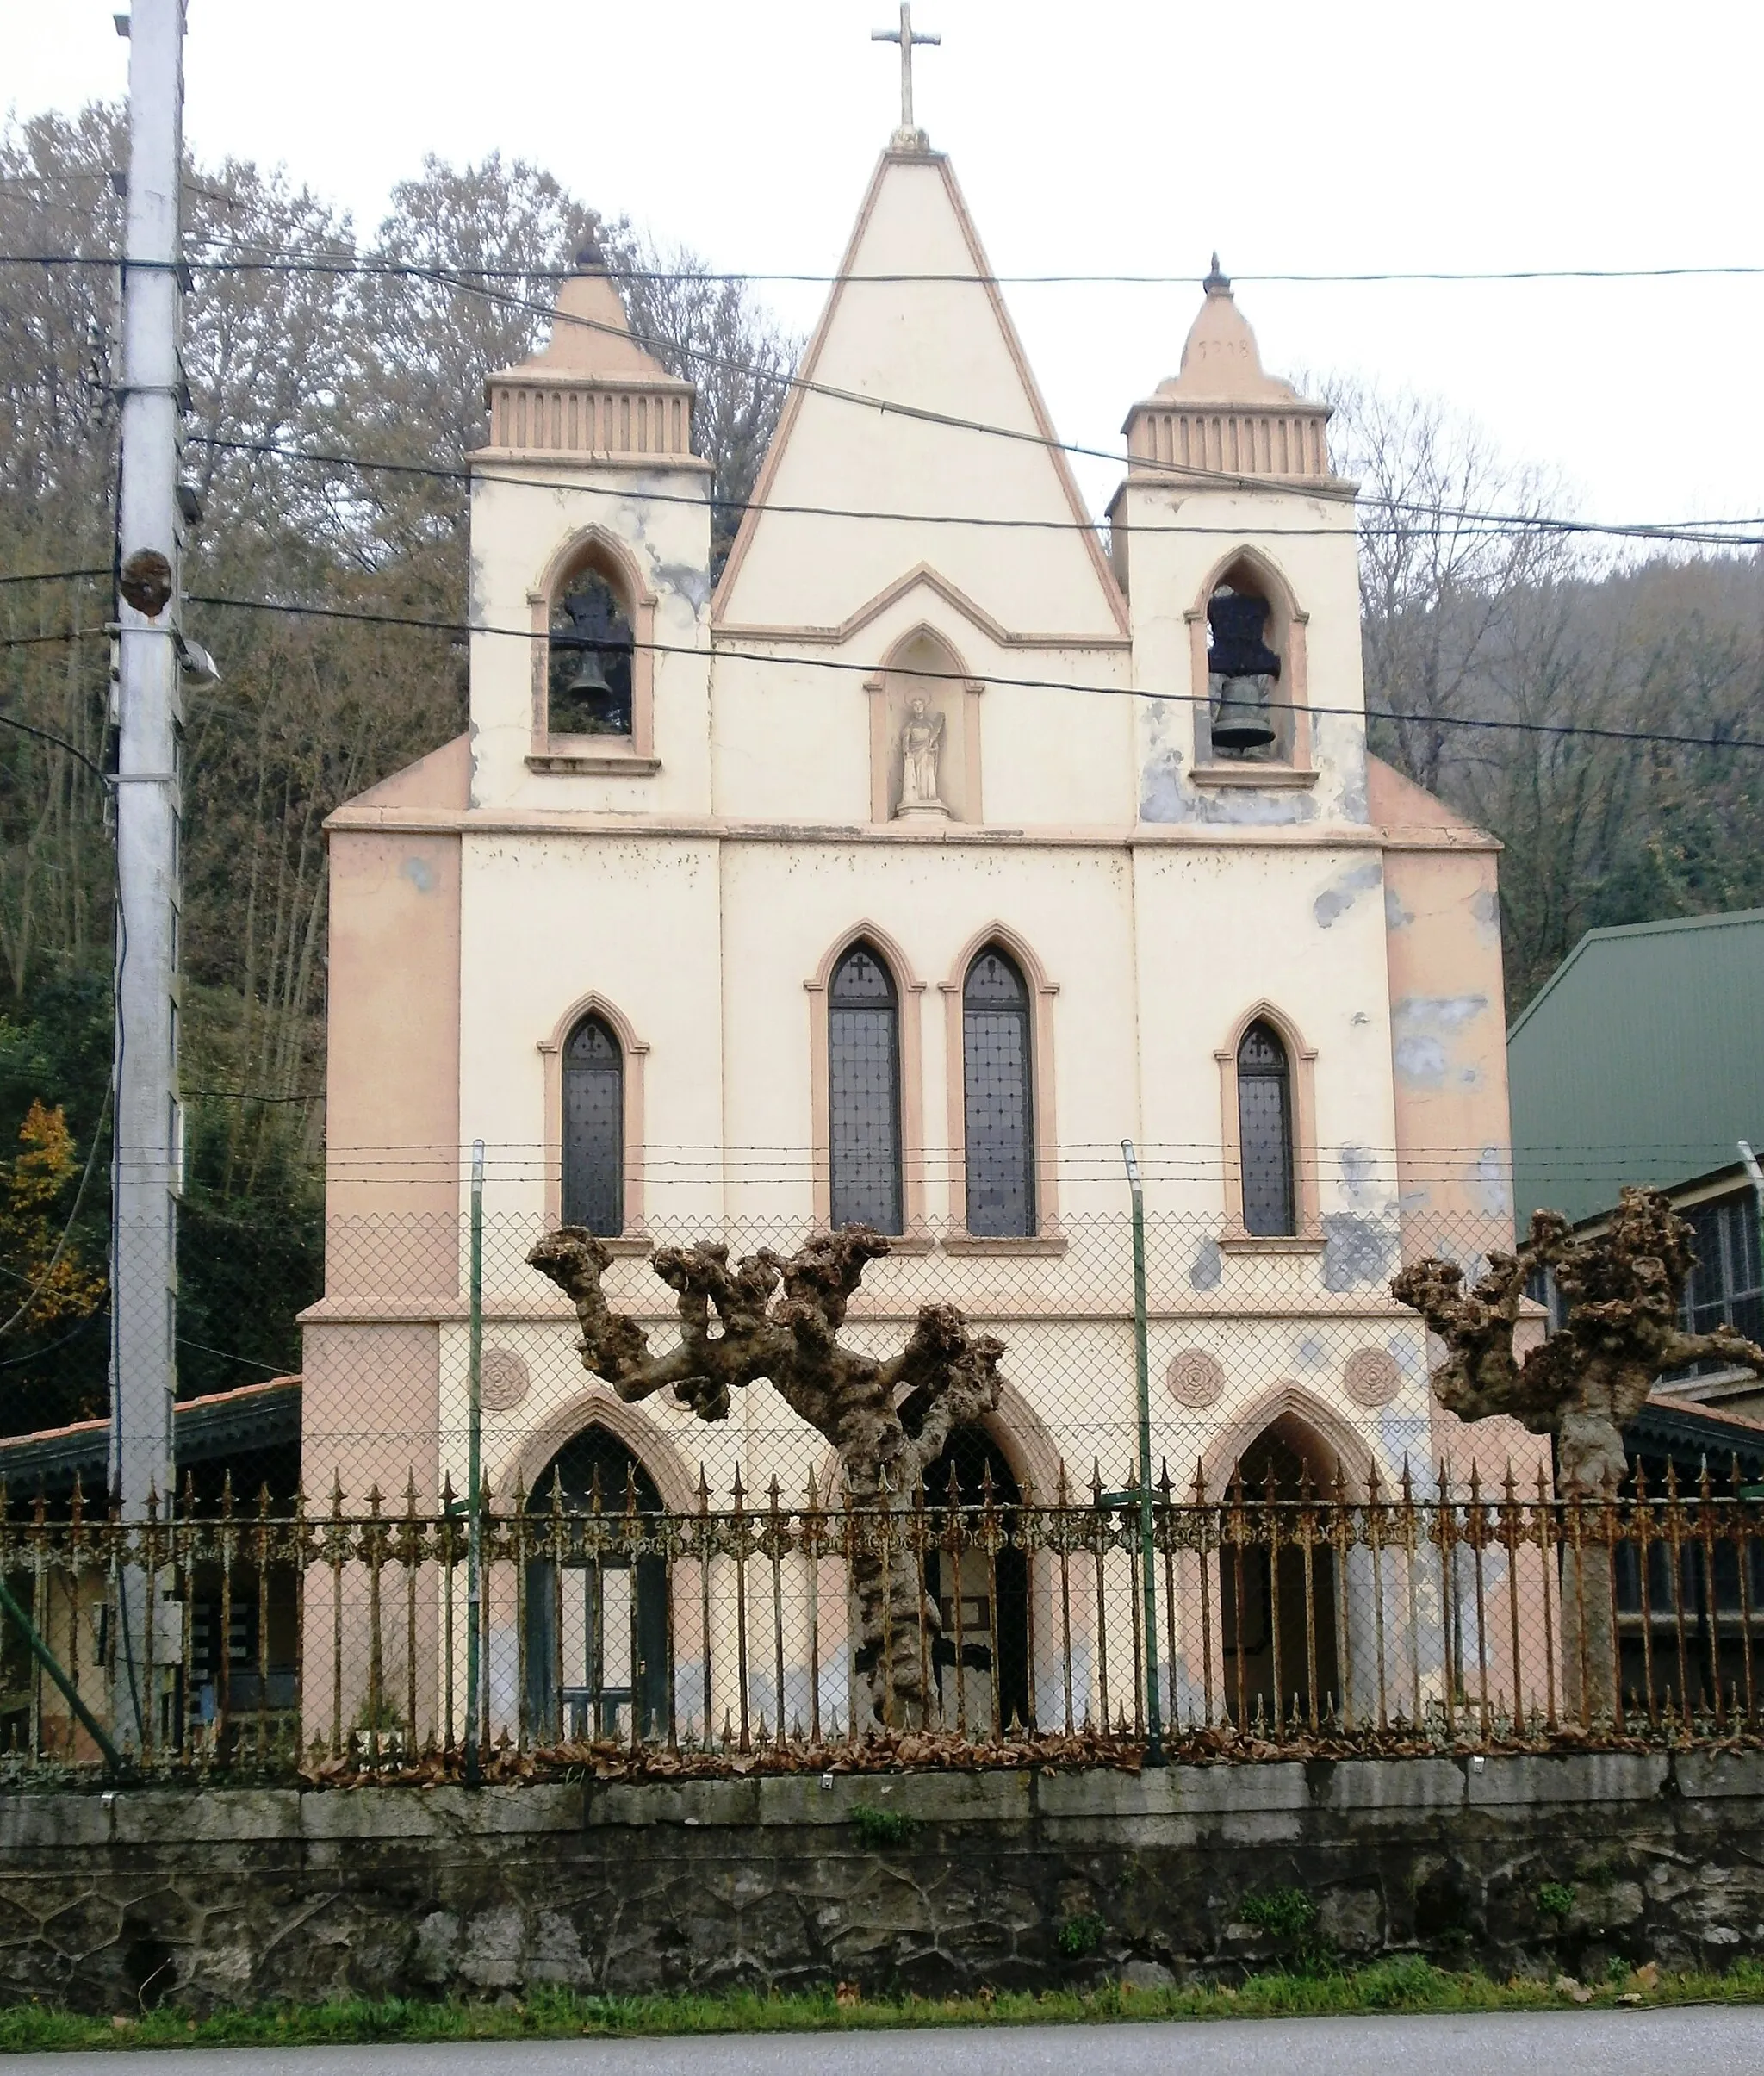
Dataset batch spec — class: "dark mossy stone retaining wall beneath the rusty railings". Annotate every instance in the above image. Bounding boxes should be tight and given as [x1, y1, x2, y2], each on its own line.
[0, 1752, 1764, 2011]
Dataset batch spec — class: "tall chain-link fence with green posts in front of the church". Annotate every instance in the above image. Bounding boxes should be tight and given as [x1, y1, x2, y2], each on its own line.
[0, 1216, 1764, 1779]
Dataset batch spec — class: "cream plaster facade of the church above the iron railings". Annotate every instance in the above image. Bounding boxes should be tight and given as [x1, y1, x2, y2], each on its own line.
[309, 158, 1544, 1561]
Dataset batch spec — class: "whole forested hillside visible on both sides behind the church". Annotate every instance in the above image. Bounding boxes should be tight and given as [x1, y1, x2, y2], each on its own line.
[0, 108, 1764, 1433]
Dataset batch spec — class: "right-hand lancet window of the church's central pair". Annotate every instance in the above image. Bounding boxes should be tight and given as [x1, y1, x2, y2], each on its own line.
[961, 948, 1035, 1240]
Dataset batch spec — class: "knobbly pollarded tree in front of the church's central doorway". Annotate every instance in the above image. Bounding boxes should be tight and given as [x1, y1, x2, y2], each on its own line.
[527, 1225, 1004, 1723]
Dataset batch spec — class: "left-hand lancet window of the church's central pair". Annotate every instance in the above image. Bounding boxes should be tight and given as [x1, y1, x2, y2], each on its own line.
[828, 945, 905, 1234]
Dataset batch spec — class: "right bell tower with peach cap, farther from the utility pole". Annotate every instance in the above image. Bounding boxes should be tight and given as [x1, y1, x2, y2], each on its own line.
[1109, 253, 1365, 822]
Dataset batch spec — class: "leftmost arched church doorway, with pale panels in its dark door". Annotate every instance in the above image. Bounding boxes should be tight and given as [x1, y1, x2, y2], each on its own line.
[525, 1422, 668, 1742]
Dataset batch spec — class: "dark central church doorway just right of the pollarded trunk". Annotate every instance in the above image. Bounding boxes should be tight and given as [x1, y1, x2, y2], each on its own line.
[923, 1426, 1034, 1740]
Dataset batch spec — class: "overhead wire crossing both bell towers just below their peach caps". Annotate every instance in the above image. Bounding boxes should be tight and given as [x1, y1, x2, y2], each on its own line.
[189, 434, 1764, 548]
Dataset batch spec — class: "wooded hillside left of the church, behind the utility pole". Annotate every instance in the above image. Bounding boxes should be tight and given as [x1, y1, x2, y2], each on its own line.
[0, 108, 795, 1430]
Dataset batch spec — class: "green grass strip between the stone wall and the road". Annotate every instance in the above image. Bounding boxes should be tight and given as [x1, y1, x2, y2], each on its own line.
[0, 1958, 1764, 2053]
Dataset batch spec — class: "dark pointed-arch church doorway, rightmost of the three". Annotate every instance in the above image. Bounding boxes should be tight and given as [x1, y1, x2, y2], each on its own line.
[1218, 1414, 1343, 1730]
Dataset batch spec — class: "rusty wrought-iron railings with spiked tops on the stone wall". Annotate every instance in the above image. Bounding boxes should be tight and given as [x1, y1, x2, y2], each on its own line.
[0, 1464, 1764, 1779]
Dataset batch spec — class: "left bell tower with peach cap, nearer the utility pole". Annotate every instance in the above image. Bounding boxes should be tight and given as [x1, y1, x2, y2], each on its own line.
[469, 239, 710, 811]
